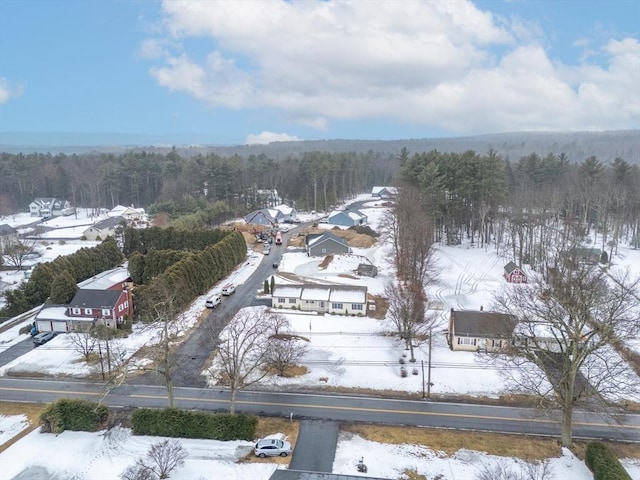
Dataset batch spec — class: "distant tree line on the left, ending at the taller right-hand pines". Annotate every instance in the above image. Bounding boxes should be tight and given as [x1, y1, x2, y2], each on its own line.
[0, 149, 397, 216]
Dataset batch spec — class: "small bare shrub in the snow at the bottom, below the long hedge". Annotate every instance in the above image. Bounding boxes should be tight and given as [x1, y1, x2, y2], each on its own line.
[121, 439, 187, 480]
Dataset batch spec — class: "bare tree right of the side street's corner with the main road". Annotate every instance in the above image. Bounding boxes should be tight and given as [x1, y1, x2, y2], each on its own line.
[209, 309, 278, 414]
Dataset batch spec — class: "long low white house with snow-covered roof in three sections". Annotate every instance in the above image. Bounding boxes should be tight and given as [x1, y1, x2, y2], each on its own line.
[271, 284, 367, 316]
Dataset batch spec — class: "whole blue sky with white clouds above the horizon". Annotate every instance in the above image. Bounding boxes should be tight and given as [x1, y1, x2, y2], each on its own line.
[0, 0, 640, 145]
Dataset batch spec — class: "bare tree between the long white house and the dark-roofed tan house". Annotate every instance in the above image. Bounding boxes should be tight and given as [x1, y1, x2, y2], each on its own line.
[385, 283, 436, 362]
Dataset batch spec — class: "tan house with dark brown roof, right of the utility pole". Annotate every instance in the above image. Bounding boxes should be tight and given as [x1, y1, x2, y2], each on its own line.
[447, 308, 518, 352]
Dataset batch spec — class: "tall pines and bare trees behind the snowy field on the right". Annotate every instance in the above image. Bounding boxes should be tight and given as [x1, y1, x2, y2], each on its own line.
[399, 150, 640, 266]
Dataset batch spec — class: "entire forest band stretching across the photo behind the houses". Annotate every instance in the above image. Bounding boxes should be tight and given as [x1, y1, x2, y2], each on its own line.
[0, 148, 640, 266]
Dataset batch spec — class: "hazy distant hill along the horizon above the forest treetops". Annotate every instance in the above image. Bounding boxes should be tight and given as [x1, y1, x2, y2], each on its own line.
[0, 130, 640, 164]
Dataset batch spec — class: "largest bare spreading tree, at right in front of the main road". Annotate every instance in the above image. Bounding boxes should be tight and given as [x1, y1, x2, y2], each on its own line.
[495, 251, 640, 447]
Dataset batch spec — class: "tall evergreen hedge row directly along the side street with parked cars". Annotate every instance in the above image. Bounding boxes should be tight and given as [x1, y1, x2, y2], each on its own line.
[132, 232, 247, 320]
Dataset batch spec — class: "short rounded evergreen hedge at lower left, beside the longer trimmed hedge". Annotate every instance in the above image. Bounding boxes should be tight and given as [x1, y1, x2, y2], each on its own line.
[40, 398, 109, 433]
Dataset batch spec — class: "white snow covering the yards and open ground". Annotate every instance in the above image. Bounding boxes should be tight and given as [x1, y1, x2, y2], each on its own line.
[0, 197, 640, 480]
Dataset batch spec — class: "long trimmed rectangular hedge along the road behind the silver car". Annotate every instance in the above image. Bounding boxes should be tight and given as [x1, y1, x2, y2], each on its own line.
[131, 408, 258, 440]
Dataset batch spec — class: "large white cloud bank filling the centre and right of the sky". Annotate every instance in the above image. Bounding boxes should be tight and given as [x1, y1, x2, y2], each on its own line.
[141, 0, 640, 133]
